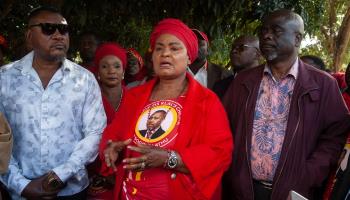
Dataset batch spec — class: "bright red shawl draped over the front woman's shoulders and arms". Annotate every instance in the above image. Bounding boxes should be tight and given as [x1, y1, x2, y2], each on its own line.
[100, 74, 233, 200]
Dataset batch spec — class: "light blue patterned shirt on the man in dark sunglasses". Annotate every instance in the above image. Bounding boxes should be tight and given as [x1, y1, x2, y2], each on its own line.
[0, 52, 106, 199]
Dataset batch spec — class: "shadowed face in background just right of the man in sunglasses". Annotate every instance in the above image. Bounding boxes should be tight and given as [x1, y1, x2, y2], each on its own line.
[79, 35, 98, 62]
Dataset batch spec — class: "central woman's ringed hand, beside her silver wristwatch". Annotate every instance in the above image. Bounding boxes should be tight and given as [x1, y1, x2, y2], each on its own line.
[123, 144, 168, 171]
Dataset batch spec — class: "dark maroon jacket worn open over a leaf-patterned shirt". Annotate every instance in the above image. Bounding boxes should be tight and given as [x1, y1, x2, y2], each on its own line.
[223, 61, 350, 200]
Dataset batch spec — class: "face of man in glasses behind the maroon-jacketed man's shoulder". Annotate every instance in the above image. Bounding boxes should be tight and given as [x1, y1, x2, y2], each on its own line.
[230, 38, 259, 72]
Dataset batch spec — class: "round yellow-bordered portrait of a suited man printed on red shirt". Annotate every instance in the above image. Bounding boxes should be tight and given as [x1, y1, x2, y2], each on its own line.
[135, 101, 182, 147]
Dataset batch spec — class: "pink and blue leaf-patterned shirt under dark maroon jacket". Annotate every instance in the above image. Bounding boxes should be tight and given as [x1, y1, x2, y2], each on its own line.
[250, 59, 298, 181]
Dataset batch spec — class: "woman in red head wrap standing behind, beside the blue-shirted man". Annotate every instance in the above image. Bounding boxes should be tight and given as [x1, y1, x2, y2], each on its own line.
[88, 43, 127, 199]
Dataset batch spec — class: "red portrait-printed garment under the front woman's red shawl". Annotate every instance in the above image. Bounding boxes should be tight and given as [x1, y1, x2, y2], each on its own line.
[121, 96, 185, 200]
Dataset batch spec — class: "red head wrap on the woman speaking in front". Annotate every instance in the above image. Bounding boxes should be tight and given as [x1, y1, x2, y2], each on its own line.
[150, 18, 198, 62]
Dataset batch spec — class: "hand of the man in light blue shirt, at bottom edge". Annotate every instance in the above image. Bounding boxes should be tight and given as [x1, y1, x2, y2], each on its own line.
[21, 174, 59, 199]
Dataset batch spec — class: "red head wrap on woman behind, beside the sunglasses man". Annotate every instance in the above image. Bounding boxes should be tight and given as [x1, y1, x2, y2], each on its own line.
[94, 43, 127, 69]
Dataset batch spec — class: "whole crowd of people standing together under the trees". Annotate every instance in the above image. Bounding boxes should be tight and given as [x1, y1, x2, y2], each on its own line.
[0, 6, 350, 200]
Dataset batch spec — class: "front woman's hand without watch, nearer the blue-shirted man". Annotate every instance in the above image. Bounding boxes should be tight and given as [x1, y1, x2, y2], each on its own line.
[103, 139, 132, 171]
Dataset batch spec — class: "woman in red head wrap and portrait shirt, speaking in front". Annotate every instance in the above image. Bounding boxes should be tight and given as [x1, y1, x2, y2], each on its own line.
[100, 19, 233, 200]
